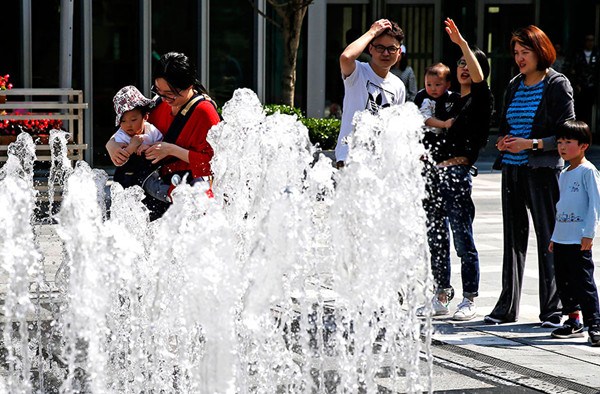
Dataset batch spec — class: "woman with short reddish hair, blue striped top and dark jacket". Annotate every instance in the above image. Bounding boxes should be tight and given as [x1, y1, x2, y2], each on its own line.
[484, 25, 575, 327]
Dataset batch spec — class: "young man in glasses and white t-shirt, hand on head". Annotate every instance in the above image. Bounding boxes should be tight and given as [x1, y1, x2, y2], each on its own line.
[335, 19, 406, 168]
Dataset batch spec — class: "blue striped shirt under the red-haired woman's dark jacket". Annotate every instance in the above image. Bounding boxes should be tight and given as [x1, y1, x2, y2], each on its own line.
[502, 81, 544, 166]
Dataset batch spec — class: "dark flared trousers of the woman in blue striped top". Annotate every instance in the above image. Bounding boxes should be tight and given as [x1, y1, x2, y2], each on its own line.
[490, 165, 561, 321]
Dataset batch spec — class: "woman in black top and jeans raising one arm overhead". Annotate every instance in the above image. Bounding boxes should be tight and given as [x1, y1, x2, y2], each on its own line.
[417, 18, 492, 321]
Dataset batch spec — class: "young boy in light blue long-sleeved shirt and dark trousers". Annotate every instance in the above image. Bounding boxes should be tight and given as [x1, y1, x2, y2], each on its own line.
[548, 120, 600, 346]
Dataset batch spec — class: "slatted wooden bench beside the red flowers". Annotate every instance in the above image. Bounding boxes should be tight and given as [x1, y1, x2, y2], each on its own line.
[0, 88, 88, 162]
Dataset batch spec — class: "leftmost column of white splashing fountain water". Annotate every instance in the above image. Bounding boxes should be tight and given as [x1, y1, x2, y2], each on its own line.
[0, 133, 41, 393]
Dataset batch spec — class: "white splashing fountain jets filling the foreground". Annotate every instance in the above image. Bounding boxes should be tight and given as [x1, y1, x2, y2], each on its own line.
[0, 89, 431, 393]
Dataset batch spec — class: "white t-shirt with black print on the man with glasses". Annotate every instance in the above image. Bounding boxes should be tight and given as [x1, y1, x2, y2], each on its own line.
[335, 61, 406, 161]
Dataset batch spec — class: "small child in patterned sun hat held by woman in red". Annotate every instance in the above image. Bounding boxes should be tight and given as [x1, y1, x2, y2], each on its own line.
[113, 85, 163, 187]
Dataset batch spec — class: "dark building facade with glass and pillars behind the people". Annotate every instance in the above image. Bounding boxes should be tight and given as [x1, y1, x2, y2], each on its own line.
[0, 0, 600, 167]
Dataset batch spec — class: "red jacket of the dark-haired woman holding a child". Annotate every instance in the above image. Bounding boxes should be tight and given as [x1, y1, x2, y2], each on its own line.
[148, 100, 220, 178]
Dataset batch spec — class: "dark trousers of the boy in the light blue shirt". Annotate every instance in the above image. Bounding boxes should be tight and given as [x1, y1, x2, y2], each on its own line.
[554, 243, 600, 326]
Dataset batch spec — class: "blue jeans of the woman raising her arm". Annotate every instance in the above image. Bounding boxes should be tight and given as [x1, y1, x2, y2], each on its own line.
[423, 165, 479, 298]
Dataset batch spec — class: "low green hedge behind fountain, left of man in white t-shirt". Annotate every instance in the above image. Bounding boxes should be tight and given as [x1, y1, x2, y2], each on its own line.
[264, 104, 341, 150]
